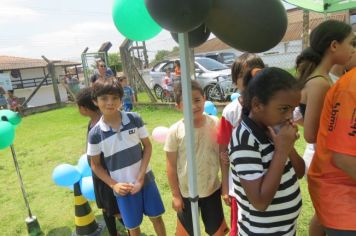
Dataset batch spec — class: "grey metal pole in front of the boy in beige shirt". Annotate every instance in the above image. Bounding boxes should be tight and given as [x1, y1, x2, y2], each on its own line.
[178, 33, 200, 236]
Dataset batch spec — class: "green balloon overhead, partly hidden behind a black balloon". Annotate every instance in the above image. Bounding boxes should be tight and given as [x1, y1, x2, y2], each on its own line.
[112, 0, 162, 41]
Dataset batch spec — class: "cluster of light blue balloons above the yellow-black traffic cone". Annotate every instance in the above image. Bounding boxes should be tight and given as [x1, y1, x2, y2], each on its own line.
[52, 154, 95, 201]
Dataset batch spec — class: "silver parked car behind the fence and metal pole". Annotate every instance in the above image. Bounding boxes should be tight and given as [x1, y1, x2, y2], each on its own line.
[150, 57, 233, 101]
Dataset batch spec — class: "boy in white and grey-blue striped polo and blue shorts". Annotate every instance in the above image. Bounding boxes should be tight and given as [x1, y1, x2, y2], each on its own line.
[87, 78, 166, 236]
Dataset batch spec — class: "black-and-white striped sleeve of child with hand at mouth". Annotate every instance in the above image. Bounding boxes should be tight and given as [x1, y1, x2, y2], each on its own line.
[230, 127, 263, 180]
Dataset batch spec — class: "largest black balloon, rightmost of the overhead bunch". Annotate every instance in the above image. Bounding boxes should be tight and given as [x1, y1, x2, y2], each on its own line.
[206, 0, 288, 53]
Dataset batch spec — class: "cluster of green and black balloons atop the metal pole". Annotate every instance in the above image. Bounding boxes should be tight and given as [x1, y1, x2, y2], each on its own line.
[112, 0, 287, 53]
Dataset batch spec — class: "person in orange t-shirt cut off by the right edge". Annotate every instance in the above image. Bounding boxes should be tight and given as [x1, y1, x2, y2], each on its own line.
[308, 69, 356, 236]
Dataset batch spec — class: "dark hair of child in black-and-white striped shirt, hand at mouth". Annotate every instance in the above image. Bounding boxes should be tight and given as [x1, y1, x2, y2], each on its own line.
[242, 67, 299, 110]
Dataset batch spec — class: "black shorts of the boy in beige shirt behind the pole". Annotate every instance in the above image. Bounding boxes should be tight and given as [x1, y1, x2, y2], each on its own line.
[177, 189, 228, 235]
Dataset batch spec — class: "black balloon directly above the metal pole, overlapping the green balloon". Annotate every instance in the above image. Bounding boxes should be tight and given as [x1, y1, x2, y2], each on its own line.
[145, 0, 213, 33]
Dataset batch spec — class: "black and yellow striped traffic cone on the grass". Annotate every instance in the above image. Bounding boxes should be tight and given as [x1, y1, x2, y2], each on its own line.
[72, 182, 103, 236]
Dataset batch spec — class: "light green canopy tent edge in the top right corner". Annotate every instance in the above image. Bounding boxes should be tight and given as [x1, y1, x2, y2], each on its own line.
[284, 0, 356, 13]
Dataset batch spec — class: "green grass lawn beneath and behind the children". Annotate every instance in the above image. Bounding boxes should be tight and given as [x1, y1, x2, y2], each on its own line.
[0, 106, 313, 236]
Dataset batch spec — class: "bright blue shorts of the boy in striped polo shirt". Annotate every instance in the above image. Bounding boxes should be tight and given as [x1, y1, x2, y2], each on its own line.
[116, 180, 164, 229]
